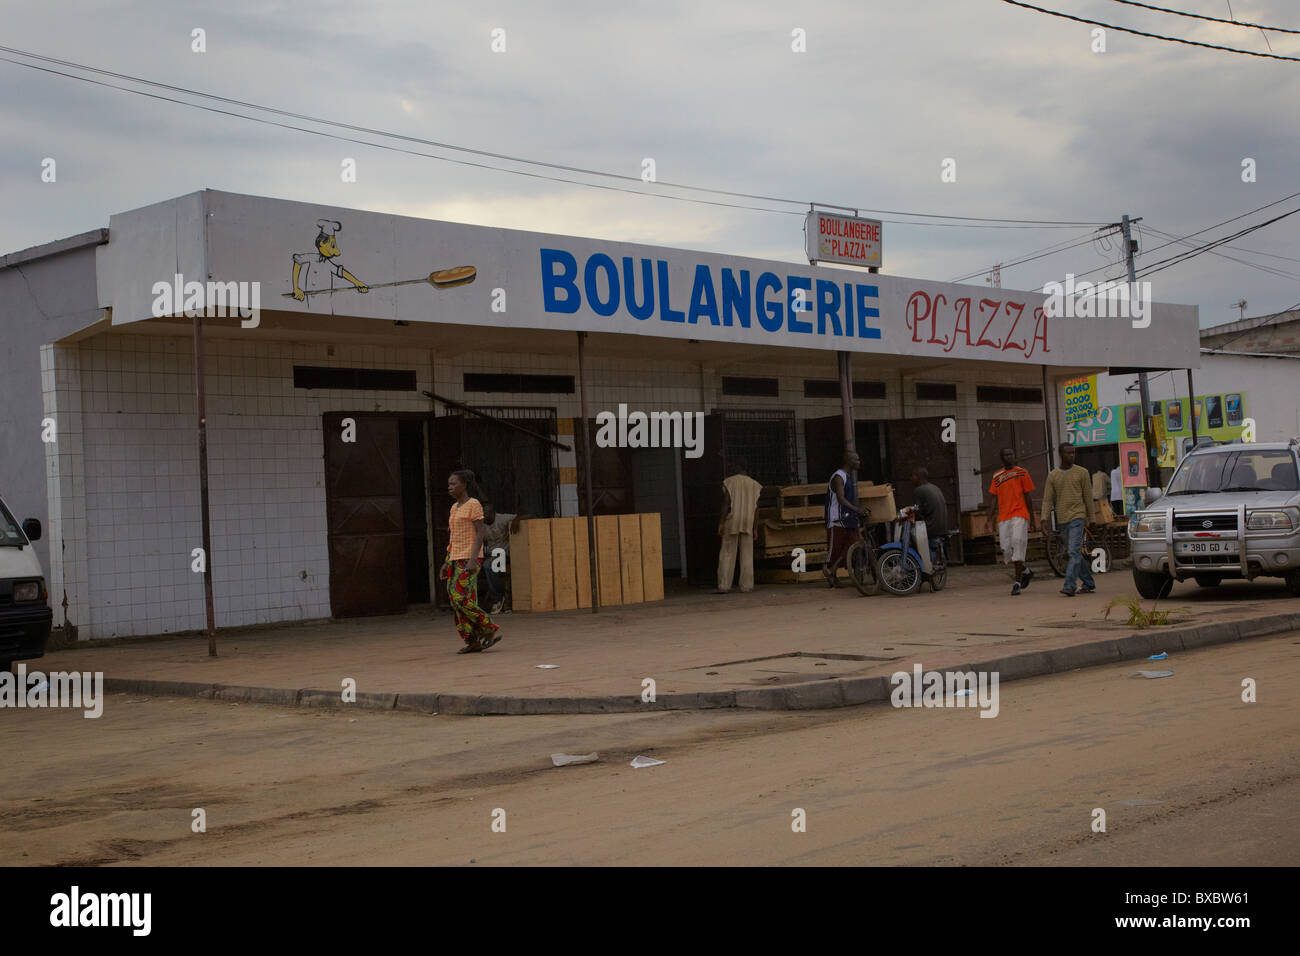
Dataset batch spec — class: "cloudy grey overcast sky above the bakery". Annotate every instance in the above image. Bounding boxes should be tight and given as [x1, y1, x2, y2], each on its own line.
[0, 0, 1300, 325]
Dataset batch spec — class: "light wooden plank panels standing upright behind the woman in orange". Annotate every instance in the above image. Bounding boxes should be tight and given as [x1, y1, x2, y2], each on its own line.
[510, 512, 663, 611]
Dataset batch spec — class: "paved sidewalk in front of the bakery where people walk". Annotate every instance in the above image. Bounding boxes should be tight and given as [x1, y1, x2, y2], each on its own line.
[40, 566, 1300, 713]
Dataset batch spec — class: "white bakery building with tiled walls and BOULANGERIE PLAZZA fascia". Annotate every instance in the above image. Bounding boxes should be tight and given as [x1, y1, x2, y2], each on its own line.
[0, 190, 1196, 639]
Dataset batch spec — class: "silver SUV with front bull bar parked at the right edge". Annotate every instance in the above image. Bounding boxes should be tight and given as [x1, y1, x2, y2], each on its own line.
[1128, 438, 1300, 597]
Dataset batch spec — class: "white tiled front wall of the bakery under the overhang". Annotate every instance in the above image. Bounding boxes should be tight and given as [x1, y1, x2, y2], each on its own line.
[42, 333, 1041, 637]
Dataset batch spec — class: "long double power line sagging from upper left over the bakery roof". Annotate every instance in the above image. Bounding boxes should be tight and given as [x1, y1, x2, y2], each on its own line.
[0, 46, 1097, 229]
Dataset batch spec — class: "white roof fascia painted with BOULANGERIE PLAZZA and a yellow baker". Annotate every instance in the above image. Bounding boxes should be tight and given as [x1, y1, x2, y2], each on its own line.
[99, 190, 1200, 367]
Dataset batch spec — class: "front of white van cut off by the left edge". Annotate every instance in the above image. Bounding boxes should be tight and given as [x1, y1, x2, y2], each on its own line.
[0, 498, 55, 670]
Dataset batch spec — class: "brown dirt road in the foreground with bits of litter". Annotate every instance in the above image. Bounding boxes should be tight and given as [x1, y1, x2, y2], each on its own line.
[0, 635, 1300, 865]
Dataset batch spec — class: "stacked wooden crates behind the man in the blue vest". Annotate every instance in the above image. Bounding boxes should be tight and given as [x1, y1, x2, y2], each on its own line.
[754, 481, 898, 584]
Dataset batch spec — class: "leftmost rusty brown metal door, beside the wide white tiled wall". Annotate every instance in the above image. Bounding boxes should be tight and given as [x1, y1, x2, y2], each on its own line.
[322, 412, 407, 618]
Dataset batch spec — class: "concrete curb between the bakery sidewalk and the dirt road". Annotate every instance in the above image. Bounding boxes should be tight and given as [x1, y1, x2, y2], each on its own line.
[104, 613, 1300, 717]
